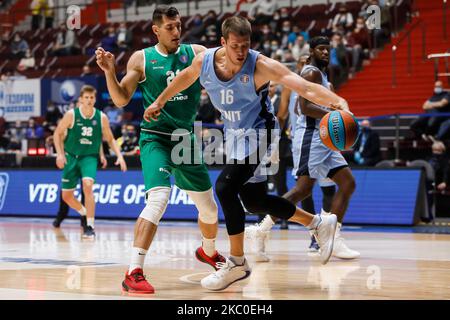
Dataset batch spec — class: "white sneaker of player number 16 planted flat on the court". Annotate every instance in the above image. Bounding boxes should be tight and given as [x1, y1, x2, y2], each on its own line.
[200, 259, 251, 291]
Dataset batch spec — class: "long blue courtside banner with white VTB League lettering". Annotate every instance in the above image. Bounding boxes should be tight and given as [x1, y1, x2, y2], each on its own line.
[0, 169, 421, 225]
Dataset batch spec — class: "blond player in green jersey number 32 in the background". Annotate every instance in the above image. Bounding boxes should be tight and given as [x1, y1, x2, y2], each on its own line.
[53, 85, 127, 238]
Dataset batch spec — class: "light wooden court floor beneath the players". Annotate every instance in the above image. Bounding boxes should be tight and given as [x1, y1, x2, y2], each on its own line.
[0, 218, 450, 300]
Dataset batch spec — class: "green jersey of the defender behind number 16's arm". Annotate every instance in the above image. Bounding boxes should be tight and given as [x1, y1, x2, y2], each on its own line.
[139, 44, 201, 133]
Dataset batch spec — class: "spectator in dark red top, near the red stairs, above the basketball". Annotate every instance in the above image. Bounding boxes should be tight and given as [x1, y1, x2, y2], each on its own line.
[347, 18, 370, 71]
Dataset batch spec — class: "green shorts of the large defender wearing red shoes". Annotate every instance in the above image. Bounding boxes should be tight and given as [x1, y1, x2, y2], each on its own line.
[139, 131, 211, 192]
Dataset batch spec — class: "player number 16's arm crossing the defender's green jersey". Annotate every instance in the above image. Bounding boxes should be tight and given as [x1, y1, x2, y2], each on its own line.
[144, 53, 204, 121]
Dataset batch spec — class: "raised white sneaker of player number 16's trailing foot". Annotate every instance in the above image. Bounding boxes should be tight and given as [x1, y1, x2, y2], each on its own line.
[314, 214, 337, 264]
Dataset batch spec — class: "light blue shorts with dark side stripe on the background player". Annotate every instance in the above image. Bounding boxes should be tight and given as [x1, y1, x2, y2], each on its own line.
[292, 128, 348, 180]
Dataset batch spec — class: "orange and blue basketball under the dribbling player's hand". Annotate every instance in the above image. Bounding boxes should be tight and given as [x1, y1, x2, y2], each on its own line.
[319, 110, 359, 151]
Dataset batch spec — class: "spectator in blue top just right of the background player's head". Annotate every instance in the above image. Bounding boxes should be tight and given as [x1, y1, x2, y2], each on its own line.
[329, 33, 348, 89]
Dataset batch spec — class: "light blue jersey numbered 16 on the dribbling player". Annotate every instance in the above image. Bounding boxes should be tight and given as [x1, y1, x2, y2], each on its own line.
[200, 48, 277, 160]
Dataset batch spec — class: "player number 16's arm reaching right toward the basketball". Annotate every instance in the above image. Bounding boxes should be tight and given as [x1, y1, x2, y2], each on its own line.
[256, 55, 348, 110]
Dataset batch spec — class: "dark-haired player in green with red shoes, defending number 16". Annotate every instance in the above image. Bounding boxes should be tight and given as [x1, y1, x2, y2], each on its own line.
[96, 6, 225, 294]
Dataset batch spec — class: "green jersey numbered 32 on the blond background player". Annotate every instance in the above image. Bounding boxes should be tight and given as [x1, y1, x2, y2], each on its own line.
[64, 108, 102, 156]
